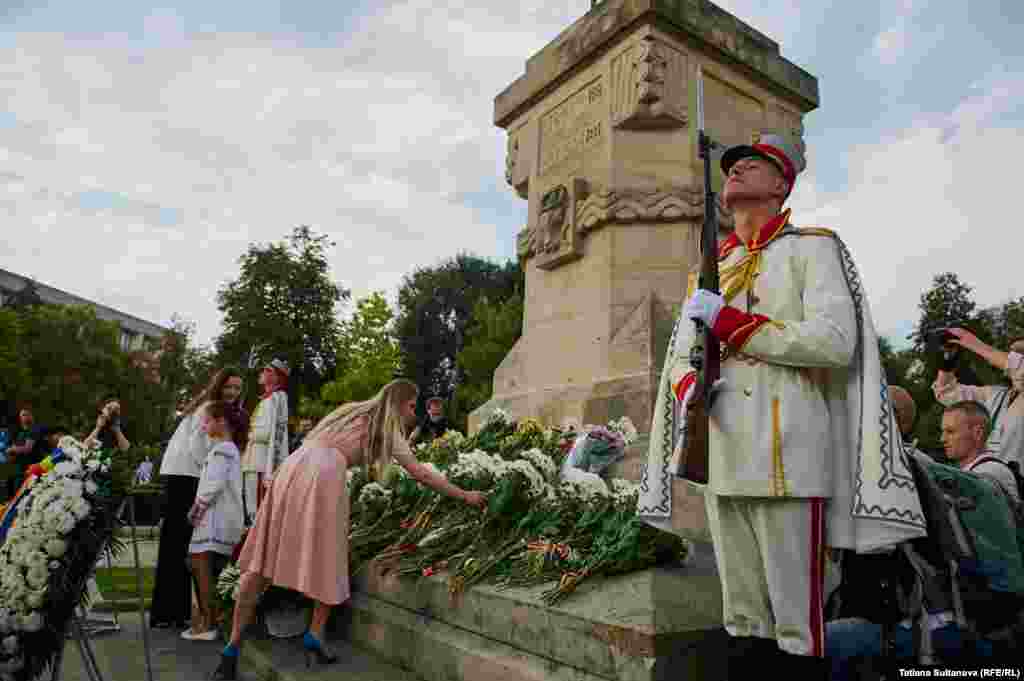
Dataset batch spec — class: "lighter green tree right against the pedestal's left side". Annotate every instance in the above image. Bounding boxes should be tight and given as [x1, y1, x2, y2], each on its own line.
[453, 294, 523, 430]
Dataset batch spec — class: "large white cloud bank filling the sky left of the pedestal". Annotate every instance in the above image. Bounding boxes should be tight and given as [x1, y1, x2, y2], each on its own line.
[0, 0, 589, 340]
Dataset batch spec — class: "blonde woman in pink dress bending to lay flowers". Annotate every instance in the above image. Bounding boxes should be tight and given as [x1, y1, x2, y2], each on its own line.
[212, 380, 486, 680]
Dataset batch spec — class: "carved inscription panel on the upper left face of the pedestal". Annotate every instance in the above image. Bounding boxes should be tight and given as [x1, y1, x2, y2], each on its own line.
[539, 79, 607, 175]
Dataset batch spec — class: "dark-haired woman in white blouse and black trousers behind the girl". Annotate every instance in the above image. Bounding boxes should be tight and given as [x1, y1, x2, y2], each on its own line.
[150, 368, 249, 629]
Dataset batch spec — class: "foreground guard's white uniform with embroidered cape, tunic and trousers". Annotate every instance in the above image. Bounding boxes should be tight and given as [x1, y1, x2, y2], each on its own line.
[638, 211, 925, 656]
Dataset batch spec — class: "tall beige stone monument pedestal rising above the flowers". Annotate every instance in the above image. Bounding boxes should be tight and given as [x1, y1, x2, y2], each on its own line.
[469, 0, 818, 493]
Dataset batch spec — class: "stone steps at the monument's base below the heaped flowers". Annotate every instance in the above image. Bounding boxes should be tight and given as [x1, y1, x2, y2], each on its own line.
[348, 540, 724, 681]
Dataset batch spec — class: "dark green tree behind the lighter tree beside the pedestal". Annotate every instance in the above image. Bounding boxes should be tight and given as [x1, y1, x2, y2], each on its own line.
[395, 254, 523, 416]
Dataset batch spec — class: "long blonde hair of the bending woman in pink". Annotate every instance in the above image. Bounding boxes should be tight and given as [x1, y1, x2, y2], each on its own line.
[306, 379, 420, 480]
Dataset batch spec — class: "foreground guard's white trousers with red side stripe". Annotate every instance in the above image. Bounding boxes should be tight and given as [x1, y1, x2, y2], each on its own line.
[705, 493, 825, 657]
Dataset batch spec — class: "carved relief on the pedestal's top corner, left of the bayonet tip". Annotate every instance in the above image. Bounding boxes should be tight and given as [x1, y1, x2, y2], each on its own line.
[611, 36, 687, 129]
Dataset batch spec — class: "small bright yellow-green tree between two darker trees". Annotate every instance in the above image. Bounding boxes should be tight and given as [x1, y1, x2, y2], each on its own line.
[319, 292, 401, 405]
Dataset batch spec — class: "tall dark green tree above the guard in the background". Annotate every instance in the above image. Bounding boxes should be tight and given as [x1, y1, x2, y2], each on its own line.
[216, 226, 350, 410]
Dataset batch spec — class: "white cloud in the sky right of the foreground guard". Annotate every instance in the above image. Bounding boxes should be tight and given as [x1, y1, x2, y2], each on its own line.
[793, 71, 1024, 333]
